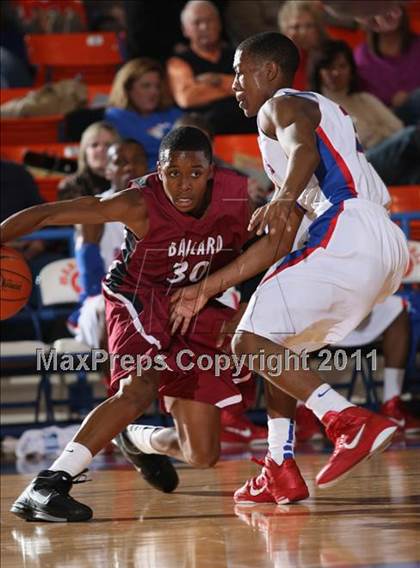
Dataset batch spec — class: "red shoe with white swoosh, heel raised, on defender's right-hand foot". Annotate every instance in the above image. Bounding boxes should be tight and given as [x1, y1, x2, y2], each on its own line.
[316, 406, 397, 487]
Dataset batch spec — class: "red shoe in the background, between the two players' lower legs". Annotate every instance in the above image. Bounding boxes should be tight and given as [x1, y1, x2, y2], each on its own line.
[221, 410, 268, 445]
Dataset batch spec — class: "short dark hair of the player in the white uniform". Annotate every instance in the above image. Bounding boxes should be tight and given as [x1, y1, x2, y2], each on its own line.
[237, 32, 300, 79]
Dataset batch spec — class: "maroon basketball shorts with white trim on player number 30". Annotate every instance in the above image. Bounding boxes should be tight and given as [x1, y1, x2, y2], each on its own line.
[104, 289, 255, 411]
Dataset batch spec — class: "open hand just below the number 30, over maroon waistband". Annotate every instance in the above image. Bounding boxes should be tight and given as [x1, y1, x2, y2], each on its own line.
[169, 282, 209, 335]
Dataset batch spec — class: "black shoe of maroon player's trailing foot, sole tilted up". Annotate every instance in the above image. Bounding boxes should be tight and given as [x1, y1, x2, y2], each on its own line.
[113, 430, 179, 493]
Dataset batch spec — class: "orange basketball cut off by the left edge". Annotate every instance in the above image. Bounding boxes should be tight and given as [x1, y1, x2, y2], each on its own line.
[0, 247, 32, 320]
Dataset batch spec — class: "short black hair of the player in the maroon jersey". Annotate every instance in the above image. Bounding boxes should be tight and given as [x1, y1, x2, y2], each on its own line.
[159, 126, 213, 163]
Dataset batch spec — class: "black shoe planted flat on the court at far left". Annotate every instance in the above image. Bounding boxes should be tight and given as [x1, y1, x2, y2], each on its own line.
[10, 469, 93, 523]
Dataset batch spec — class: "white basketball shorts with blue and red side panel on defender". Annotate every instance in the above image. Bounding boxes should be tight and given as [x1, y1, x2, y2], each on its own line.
[237, 198, 409, 353]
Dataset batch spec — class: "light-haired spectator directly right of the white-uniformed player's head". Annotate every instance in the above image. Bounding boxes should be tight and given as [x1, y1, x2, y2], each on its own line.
[278, 0, 327, 90]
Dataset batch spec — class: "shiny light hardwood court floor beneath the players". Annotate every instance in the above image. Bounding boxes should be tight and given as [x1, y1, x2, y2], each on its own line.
[1, 448, 420, 568]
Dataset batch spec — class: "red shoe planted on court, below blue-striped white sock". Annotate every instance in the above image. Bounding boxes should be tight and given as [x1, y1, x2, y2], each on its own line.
[233, 455, 309, 505]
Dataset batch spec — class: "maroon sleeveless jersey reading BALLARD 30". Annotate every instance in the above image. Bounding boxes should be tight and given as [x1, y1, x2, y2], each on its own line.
[105, 168, 250, 303]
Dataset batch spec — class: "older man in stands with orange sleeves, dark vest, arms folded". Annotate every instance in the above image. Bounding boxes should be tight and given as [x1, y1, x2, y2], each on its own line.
[167, 0, 256, 134]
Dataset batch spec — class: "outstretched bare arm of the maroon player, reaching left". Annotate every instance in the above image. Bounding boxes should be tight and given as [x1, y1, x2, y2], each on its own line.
[0, 189, 147, 243]
